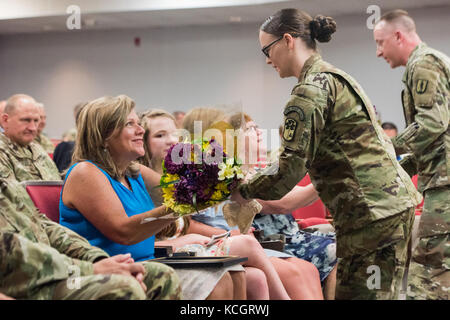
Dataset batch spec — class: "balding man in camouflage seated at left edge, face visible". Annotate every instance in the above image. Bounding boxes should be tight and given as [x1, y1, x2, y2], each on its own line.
[0, 94, 61, 182]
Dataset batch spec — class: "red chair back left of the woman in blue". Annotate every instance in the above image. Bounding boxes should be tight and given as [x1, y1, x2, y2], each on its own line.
[22, 180, 63, 222]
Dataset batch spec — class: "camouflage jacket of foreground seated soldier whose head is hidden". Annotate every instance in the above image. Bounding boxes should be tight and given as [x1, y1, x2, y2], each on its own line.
[0, 176, 108, 298]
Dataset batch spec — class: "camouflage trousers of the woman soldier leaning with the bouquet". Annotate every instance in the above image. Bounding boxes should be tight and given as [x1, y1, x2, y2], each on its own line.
[336, 208, 414, 300]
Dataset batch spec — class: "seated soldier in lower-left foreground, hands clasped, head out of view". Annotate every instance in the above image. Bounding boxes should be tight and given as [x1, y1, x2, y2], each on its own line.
[0, 175, 181, 299]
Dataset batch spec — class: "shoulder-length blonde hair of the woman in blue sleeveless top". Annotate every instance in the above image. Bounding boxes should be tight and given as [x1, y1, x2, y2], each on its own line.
[72, 95, 139, 179]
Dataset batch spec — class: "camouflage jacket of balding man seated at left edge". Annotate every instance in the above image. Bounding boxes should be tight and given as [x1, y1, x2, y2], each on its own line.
[0, 133, 61, 182]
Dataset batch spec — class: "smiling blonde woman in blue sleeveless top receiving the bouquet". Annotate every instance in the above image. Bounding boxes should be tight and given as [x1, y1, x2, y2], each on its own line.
[60, 95, 242, 299]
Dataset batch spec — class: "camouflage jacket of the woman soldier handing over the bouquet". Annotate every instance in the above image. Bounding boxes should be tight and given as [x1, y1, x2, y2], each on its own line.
[239, 54, 421, 256]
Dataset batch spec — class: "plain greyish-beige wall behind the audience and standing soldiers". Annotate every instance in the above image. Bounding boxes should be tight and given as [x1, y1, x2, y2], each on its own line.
[0, 7, 450, 143]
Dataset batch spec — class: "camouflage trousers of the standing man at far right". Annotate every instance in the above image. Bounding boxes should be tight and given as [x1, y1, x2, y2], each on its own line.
[406, 187, 450, 300]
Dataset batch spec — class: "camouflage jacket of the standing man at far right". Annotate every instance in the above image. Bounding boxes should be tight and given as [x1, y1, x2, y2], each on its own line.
[393, 43, 450, 192]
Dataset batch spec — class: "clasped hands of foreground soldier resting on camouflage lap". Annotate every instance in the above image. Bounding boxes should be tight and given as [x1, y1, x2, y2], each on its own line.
[94, 253, 147, 291]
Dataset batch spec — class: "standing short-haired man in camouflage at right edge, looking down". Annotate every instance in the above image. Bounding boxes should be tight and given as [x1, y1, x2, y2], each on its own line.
[374, 10, 450, 300]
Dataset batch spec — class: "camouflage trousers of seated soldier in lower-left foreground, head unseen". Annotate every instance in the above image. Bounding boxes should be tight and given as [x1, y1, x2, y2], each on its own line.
[50, 261, 181, 300]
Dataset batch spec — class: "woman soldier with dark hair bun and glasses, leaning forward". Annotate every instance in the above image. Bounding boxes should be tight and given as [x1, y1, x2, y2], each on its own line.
[232, 9, 421, 299]
